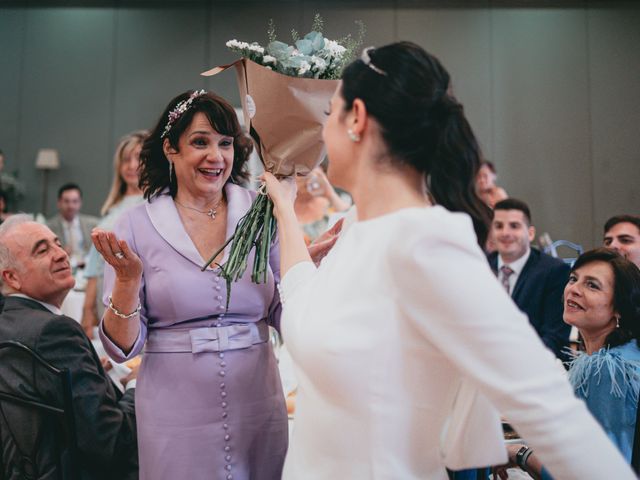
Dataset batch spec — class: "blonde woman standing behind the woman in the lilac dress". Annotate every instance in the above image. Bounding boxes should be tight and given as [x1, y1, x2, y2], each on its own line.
[82, 130, 148, 338]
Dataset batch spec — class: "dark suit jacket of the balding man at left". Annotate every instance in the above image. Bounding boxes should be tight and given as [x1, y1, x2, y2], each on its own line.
[0, 296, 138, 480]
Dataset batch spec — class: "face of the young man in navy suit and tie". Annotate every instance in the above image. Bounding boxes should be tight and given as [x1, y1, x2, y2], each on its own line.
[491, 210, 536, 263]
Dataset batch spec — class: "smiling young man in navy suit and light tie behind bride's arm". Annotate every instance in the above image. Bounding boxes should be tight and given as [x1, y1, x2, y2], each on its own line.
[489, 198, 571, 360]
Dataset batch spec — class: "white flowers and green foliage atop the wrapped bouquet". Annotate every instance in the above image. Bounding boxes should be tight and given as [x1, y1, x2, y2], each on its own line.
[226, 14, 365, 80]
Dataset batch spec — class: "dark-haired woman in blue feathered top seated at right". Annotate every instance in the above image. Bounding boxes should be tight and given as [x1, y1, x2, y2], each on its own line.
[499, 248, 640, 479]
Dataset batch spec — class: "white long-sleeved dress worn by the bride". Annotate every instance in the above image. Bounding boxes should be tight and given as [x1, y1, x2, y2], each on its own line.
[280, 207, 635, 480]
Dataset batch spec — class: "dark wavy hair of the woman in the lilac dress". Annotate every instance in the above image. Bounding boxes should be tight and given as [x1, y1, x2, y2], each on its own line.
[140, 90, 253, 199]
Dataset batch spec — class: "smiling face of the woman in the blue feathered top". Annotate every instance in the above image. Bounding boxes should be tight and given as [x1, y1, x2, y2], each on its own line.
[563, 261, 616, 336]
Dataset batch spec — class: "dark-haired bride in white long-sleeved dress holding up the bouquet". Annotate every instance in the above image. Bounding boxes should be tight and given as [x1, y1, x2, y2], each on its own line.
[265, 42, 635, 480]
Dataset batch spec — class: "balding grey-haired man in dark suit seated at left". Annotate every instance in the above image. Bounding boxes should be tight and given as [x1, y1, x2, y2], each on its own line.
[0, 215, 137, 480]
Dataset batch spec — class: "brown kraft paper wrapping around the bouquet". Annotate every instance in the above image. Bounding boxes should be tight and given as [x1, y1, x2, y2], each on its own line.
[202, 58, 338, 176]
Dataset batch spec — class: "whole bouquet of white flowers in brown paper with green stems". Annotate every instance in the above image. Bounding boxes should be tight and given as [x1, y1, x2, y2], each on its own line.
[203, 15, 364, 303]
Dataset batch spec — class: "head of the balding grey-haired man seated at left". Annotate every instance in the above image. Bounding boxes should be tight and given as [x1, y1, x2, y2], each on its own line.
[1, 222, 75, 307]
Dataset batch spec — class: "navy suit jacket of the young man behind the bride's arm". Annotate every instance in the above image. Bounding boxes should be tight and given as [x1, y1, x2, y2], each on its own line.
[489, 248, 571, 360]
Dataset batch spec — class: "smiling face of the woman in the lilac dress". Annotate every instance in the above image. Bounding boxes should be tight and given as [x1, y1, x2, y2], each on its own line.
[164, 112, 234, 201]
